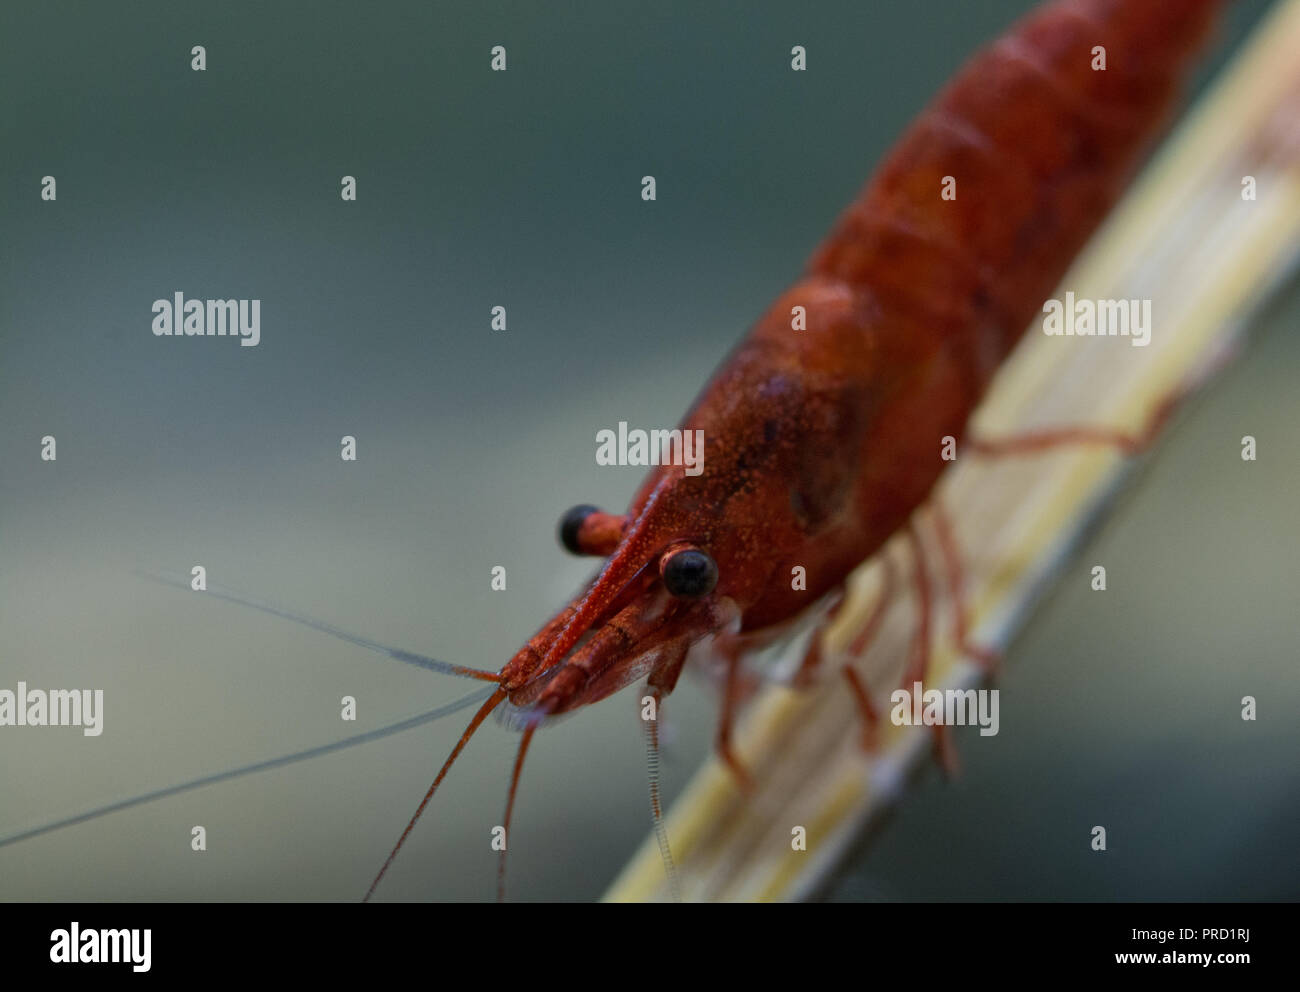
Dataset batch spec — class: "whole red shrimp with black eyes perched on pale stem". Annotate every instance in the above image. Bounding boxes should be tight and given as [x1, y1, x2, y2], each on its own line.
[367, 0, 1222, 898]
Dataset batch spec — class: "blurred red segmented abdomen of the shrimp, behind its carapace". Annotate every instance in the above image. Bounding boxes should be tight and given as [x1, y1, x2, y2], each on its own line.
[810, 0, 1222, 384]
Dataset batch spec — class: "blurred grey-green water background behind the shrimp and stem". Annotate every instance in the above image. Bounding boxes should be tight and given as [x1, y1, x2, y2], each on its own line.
[0, 0, 1300, 900]
